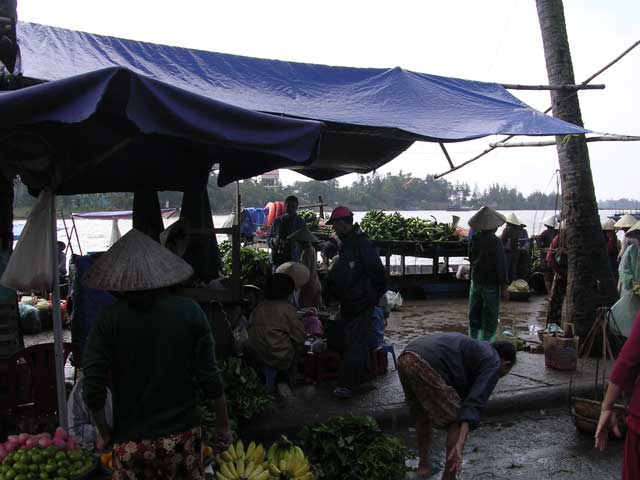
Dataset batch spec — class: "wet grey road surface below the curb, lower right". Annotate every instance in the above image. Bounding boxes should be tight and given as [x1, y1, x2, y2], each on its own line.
[396, 409, 623, 480]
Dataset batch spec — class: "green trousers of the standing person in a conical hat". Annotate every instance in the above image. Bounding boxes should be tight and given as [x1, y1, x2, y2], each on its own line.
[469, 280, 500, 342]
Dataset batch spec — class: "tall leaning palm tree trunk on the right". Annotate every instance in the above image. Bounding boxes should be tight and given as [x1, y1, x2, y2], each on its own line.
[536, 0, 616, 338]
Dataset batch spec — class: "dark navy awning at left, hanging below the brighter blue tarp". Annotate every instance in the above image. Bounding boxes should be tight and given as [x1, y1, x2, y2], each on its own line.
[0, 67, 323, 195]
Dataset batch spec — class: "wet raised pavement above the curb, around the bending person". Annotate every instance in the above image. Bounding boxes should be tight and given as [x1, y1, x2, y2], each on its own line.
[243, 296, 608, 438]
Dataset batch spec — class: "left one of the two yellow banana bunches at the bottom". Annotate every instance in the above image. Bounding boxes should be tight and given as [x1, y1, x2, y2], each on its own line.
[216, 440, 269, 480]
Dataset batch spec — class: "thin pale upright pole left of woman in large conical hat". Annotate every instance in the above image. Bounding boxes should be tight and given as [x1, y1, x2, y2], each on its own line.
[50, 193, 69, 430]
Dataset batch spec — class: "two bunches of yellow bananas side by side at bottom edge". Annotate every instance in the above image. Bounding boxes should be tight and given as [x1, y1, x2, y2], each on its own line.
[216, 435, 315, 480]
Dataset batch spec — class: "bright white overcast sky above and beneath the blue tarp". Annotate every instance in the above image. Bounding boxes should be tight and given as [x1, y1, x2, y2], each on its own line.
[18, 0, 640, 199]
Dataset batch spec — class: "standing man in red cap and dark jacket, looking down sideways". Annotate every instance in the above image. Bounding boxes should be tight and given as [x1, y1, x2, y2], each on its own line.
[327, 207, 386, 398]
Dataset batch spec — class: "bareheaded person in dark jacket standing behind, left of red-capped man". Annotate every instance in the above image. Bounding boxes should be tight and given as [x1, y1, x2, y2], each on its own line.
[269, 195, 305, 271]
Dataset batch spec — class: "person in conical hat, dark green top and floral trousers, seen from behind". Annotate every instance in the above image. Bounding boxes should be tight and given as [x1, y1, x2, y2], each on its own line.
[83, 229, 232, 480]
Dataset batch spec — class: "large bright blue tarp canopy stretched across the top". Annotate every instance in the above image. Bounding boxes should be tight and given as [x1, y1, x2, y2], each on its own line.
[10, 22, 587, 179]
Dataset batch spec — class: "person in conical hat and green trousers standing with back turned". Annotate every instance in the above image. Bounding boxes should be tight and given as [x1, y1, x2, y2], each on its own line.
[469, 207, 507, 341]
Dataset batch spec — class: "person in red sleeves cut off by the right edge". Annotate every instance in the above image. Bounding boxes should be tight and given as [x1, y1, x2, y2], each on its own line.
[595, 315, 640, 480]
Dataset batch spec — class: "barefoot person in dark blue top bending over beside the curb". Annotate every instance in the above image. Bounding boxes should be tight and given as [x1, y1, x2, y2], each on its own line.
[398, 333, 516, 479]
